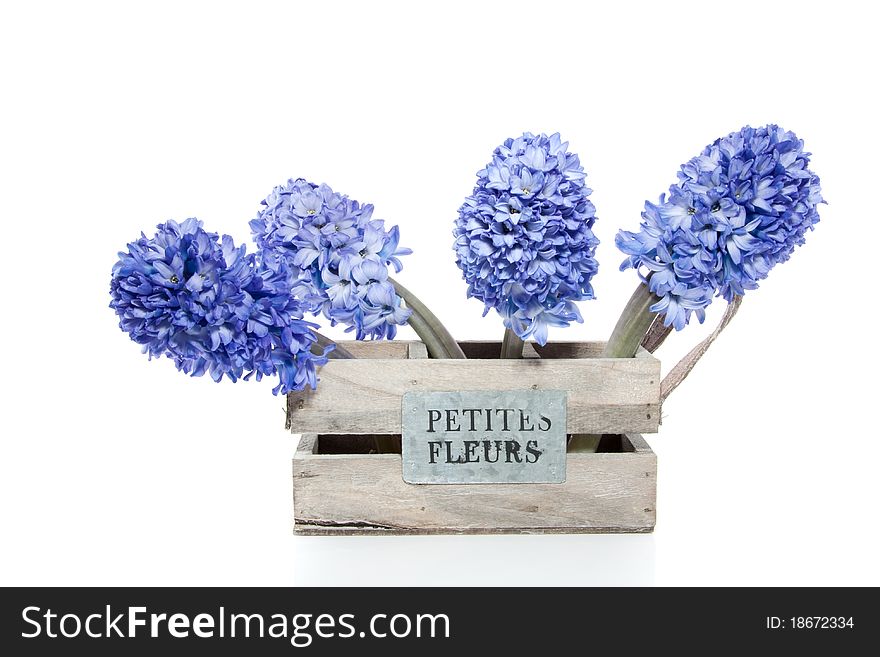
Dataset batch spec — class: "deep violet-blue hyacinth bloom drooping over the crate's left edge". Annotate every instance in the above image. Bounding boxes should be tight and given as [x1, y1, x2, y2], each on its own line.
[110, 219, 331, 394]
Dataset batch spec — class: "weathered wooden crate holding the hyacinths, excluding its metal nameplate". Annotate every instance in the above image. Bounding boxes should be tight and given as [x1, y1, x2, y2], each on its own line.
[287, 341, 660, 534]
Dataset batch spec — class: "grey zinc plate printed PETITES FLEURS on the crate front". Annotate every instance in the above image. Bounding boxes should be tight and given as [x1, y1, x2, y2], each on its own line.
[401, 390, 567, 484]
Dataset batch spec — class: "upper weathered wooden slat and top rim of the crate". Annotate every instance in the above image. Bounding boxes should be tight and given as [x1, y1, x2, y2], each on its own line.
[288, 341, 660, 434]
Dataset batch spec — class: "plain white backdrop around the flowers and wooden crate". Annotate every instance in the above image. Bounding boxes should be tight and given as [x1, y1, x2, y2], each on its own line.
[0, 0, 880, 585]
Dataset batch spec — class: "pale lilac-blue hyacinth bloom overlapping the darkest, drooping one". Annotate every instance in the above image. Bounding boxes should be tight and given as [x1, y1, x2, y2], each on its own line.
[250, 178, 411, 340]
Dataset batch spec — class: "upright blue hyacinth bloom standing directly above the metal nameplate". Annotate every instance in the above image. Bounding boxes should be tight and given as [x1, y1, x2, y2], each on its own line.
[453, 133, 599, 345]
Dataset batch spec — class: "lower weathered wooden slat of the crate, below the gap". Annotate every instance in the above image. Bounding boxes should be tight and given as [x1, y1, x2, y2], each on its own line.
[293, 434, 657, 535]
